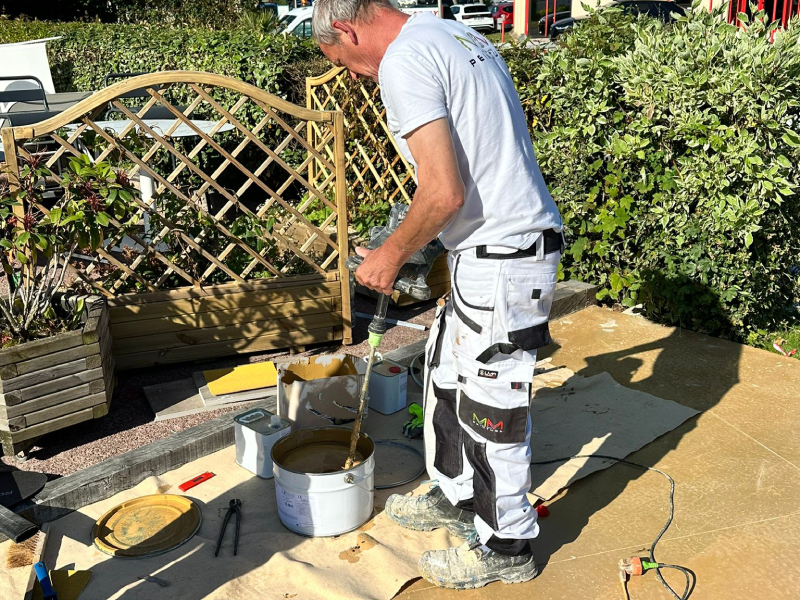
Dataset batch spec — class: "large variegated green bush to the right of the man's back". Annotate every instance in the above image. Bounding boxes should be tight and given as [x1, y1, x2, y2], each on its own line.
[506, 10, 800, 339]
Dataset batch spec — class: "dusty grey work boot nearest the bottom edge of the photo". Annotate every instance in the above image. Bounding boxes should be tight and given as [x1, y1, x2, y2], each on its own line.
[419, 536, 538, 590]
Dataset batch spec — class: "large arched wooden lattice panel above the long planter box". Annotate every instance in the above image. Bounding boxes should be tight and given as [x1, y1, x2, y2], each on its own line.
[3, 71, 349, 309]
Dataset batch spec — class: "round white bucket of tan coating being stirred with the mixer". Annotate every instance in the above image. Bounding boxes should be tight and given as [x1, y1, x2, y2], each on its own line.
[272, 427, 375, 537]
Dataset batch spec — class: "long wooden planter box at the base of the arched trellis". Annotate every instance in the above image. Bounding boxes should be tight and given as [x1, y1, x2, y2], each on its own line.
[108, 273, 350, 369]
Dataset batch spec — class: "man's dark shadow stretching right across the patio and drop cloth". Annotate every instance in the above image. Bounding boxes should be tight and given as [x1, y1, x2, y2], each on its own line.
[531, 275, 742, 565]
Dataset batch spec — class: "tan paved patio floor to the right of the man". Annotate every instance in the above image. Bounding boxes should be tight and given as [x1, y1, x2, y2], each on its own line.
[398, 307, 800, 600]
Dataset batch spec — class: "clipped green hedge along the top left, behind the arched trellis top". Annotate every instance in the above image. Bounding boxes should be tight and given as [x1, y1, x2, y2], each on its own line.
[0, 19, 322, 106]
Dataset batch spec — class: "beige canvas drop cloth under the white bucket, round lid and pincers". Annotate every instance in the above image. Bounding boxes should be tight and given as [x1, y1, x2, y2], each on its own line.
[18, 447, 460, 600]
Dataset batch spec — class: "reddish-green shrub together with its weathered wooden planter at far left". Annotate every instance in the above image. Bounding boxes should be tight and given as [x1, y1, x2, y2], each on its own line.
[0, 154, 137, 454]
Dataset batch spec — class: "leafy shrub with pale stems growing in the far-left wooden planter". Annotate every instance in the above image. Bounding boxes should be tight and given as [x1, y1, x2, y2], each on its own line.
[0, 154, 135, 344]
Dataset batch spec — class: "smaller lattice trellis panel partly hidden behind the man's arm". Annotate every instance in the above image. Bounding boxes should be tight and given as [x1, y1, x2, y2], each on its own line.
[306, 67, 416, 209]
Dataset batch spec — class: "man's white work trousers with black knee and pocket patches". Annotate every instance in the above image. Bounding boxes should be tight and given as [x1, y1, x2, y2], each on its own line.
[424, 237, 561, 550]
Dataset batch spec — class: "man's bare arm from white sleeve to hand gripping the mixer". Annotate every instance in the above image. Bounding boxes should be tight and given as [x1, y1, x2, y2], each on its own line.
[356, 118, 464, 294]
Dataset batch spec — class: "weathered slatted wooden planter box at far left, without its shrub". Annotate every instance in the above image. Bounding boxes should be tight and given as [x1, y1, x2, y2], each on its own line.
[0, 299, 114, 455]
